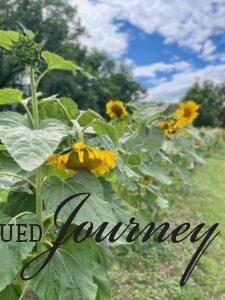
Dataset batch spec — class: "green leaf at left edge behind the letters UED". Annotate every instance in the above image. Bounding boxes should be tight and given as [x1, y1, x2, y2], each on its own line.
[0, 211, 38, 291]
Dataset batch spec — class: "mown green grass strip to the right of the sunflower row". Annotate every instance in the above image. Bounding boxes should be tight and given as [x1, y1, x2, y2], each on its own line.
[109, 147, 225, 300]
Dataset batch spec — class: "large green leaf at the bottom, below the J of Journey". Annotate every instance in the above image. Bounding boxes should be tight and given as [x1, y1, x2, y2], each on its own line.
[28, 241, 97, 300]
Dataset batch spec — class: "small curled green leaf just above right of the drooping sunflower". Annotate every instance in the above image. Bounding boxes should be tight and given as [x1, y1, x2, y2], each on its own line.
[92, 119, 118, 145]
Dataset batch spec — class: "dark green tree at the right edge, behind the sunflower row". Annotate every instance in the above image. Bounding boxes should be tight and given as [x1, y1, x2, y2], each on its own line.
[182, 81, 225, 127]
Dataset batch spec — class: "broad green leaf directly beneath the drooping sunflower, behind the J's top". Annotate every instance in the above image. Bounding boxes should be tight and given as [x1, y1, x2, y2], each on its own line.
[42, 170, 116, 228]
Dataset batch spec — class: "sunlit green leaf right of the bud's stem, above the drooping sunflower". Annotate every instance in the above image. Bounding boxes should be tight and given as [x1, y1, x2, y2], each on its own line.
[39, 98, 78, 124]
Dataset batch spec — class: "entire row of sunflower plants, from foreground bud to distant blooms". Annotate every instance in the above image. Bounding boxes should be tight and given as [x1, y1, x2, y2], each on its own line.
[0, 28, 224, 300]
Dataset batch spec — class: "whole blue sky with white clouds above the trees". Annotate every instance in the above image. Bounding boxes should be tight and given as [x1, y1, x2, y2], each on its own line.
[69, 0, 225, 102]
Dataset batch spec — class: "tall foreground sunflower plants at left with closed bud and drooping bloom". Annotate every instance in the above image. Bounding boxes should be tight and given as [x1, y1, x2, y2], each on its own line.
[0, 27, 130, 300]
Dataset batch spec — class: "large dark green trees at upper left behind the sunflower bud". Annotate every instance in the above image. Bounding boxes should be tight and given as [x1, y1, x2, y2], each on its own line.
[0, 0, 145, 113]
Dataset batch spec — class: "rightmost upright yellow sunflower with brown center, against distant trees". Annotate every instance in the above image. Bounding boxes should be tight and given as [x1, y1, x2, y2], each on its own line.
[176, 101, 199, 126]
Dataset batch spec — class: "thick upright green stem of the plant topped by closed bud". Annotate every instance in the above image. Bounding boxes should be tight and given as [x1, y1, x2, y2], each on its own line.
[29, 68, 42, 253]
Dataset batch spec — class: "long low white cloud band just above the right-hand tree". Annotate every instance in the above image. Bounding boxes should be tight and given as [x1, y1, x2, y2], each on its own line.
[144, 64, 225, 102]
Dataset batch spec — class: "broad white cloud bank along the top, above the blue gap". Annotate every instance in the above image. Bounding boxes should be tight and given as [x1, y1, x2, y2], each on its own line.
[70, 0, 225, 59]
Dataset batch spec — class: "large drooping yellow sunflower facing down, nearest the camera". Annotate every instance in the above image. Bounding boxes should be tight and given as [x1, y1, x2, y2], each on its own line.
[47, 142, 116, 175]
